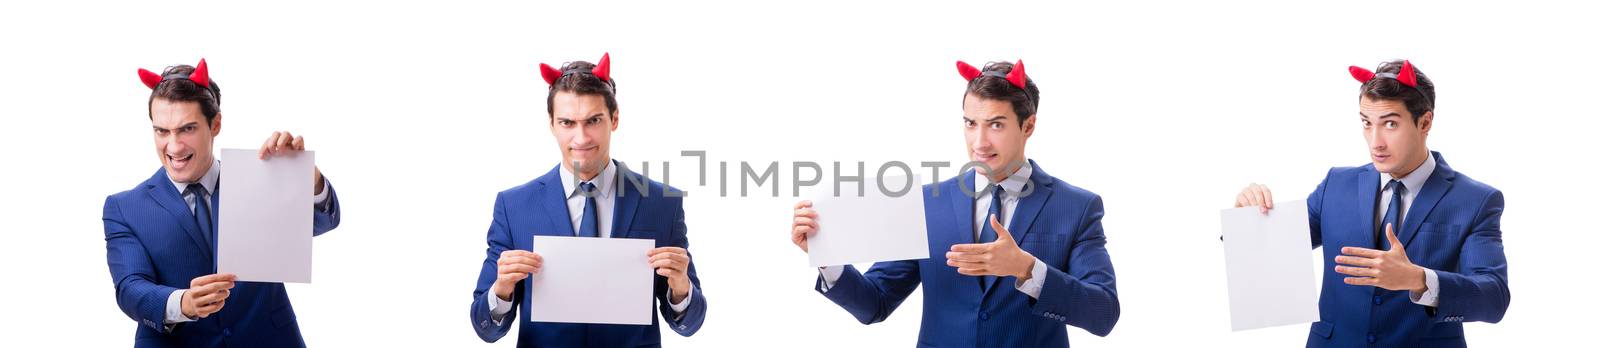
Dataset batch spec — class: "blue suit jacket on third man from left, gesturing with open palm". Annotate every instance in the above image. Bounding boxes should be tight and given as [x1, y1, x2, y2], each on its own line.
[818, 164, 1122, 346]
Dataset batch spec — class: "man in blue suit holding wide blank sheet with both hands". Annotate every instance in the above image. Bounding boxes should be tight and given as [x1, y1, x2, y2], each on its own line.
[470, 54, 706, 346]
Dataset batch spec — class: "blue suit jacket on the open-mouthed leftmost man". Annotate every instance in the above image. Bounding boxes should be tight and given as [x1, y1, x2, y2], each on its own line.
[102, 169, 339, 346]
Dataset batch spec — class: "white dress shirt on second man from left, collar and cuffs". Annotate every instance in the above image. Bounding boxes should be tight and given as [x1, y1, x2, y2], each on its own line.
[483, 161, 694, 326]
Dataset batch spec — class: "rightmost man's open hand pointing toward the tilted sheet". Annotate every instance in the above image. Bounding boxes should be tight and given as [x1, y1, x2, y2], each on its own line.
[1333, 225, 1427, 292]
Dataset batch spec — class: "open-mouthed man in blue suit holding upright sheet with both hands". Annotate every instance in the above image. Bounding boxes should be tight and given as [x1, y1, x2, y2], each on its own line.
[102, 59, 339, 346]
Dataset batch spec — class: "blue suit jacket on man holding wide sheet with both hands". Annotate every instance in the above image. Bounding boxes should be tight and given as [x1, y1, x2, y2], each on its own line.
[470, 166, 706, 346]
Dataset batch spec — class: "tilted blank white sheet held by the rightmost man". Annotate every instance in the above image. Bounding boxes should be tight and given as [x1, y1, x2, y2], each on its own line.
[1222, 201, 1318, 330]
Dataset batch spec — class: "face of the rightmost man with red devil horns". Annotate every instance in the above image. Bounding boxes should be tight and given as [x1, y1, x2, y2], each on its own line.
[1360, 96, 1434, 177]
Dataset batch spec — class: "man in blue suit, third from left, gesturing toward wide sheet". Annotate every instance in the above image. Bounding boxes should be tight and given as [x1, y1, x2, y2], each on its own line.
[790, 61, 1122, 346]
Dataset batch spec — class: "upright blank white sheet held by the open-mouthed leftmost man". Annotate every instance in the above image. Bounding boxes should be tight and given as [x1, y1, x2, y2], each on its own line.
[216, 148, 315, 283]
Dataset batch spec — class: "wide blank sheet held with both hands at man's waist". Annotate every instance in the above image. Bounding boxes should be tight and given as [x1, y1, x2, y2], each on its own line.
[528, 236, 656, 326]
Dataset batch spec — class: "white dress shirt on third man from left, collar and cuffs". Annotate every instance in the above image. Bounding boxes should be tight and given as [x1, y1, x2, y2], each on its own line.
[819, 163, 1050, 299]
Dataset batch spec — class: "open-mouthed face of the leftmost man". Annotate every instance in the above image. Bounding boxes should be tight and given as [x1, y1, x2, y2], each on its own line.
[150, 97, 222, 182]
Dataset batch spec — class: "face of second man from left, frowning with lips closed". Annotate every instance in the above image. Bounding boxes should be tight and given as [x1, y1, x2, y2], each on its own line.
[550, 91, 618, 180]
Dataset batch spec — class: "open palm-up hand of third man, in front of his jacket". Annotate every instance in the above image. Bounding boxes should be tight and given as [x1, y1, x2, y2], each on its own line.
[944, 216, 1035, 281]
